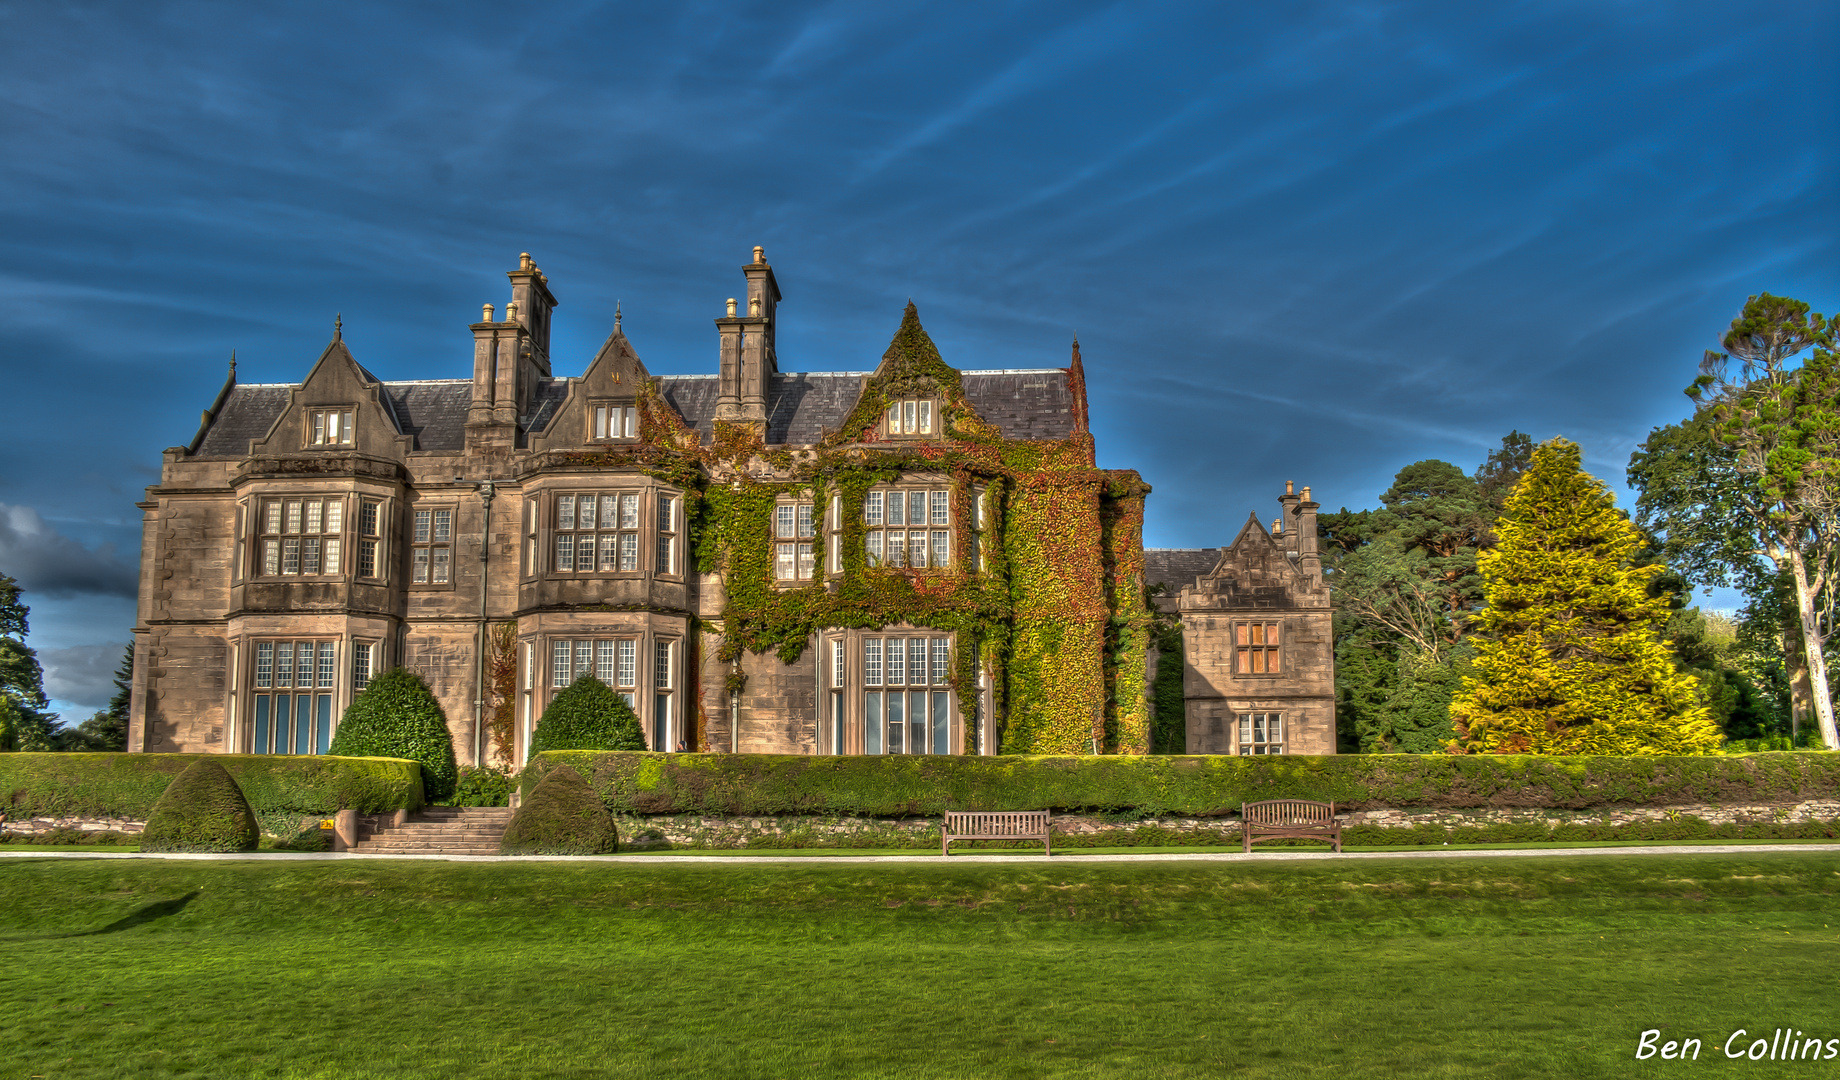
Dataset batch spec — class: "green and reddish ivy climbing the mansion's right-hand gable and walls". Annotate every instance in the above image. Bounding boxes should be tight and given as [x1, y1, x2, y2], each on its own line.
[567, 304, 1150, 754]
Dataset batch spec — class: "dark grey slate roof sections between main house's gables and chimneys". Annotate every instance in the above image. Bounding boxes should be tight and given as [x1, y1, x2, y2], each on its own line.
[195, 368, 1074, 454]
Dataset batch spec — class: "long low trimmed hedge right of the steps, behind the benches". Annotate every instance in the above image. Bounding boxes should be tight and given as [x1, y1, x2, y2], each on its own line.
[521, 751, 1840, 817]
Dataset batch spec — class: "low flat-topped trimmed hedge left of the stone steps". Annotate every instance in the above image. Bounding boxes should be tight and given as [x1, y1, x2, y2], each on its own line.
[0, 754, 421, 839]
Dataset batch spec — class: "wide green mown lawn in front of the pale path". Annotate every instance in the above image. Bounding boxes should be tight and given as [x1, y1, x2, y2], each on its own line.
[0, 850, 1840, 1080]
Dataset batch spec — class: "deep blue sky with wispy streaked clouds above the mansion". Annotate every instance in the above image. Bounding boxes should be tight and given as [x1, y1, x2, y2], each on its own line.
[0, 0, 1840, 719]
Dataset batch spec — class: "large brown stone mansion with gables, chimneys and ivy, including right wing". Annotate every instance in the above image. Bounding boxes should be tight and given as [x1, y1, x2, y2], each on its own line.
[129, 248, 1336, 767]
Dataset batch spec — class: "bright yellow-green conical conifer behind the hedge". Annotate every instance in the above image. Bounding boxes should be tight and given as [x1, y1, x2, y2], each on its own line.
[1450, 440, 1720, 754]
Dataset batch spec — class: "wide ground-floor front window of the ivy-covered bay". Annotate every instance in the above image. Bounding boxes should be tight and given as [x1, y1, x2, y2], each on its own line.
[863, 637, 951, 754]
